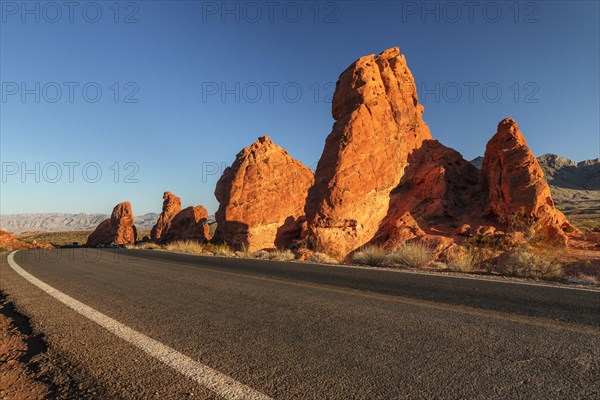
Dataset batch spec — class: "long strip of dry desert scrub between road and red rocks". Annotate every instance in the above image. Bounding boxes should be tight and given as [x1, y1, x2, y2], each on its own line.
[119, 228, 600, 285]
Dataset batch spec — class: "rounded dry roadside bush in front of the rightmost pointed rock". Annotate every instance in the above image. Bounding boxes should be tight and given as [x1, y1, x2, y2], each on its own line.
[499, 250, 564, 280]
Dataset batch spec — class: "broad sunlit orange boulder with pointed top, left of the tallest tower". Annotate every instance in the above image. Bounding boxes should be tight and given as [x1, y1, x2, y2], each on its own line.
[215, 136, 314, 251]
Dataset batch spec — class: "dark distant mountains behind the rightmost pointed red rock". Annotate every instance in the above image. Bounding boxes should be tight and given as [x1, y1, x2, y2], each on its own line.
[471, 154, 600, 215]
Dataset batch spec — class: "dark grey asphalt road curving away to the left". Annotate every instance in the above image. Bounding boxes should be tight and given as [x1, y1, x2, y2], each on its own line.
[0, 249, 600, 400]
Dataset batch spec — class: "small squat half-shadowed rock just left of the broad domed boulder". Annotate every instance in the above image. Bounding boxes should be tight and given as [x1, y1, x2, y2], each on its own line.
[163, 206, 210, 243]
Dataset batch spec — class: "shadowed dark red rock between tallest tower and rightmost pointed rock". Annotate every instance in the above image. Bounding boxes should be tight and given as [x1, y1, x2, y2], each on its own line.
[372, 140, 486, 251]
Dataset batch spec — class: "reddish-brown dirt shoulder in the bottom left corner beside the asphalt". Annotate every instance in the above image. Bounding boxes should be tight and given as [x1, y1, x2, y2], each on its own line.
[0, 291, 96, 400]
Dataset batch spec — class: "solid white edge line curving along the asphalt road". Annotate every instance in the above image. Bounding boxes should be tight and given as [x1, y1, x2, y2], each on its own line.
[8, 251, 272, 400]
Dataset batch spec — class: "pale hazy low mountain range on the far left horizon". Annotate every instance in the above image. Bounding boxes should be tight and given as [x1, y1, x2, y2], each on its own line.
[0, 213, 158, 233]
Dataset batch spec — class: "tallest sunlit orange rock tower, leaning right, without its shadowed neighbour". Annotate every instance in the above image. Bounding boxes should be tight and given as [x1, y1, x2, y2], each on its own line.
[306, 48, 431, 256]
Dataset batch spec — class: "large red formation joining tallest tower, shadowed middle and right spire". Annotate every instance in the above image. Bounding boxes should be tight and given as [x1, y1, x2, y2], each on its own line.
[305, 48, 575, 258]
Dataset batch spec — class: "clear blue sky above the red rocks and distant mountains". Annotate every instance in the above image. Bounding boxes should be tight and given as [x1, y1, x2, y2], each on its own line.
[0, 1, 600, 214]
